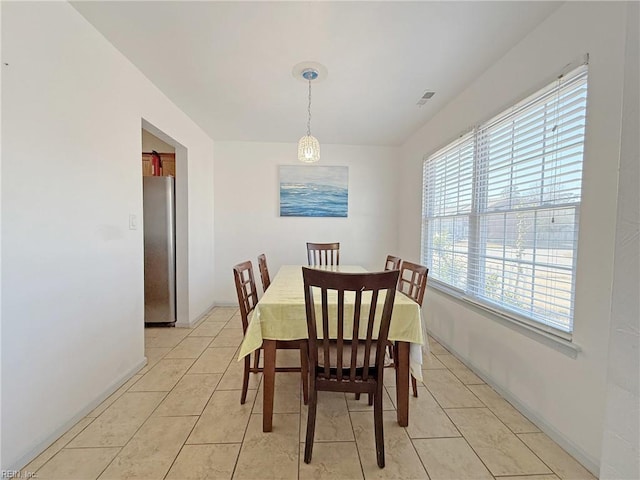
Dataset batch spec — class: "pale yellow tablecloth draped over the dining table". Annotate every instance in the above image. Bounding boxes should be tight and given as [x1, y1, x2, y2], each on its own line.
[239, 265, 424, 380]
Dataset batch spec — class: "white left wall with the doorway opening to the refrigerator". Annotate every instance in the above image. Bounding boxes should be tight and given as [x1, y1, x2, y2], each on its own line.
[1, 2, 214, 469]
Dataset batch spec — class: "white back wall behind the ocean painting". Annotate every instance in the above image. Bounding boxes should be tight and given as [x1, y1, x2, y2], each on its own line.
[214, 142, 399, 304]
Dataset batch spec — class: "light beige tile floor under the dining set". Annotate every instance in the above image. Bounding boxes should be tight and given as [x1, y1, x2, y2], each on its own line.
[23, 307, 594, 480]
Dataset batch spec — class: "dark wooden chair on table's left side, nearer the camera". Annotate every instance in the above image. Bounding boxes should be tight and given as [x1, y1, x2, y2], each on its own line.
[233, 260, 309, 405]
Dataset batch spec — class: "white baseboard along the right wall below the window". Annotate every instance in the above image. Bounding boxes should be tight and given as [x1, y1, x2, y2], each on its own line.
[429, 332, 600, 478]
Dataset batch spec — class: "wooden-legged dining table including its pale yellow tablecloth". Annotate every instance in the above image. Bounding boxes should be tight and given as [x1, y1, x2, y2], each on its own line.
[238, 265, 428, 432]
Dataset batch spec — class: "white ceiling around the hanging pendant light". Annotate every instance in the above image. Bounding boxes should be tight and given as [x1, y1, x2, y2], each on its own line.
[72, 1, 561, 146]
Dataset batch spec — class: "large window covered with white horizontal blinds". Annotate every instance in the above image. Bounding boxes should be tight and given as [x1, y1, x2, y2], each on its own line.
[422, 65, 587, 338]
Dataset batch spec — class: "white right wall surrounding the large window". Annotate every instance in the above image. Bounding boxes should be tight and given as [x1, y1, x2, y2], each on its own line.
[399, 2, 637, 473]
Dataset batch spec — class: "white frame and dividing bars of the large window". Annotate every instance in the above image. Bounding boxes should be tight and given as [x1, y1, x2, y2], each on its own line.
[420, 60, 588, 342]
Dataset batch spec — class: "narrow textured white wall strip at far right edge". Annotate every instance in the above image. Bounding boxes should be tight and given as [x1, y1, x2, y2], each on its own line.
[600, 2, 640, 480]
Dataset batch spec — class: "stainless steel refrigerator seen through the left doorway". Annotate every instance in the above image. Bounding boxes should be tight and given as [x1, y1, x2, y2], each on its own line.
[142, 177, 176, 323]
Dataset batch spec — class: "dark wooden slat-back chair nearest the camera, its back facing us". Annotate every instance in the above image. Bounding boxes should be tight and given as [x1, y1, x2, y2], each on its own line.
[302, 267, 399, 468]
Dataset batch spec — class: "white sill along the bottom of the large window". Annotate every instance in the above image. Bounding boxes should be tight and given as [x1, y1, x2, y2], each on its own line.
[427, 281, 582, 358]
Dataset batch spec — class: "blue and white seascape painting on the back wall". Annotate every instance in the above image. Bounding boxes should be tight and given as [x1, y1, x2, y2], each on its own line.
[280, 165, 349, 217]
